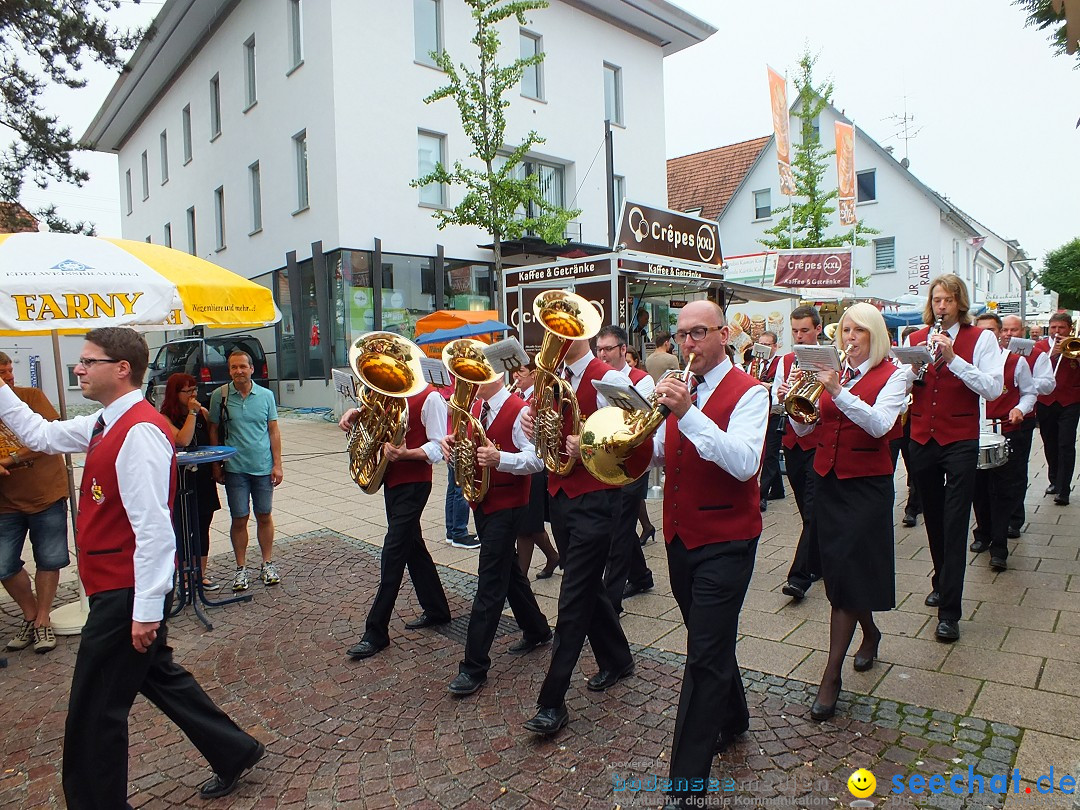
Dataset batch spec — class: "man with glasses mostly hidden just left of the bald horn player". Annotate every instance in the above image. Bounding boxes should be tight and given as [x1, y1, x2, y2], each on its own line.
[596, 326, 656, 613]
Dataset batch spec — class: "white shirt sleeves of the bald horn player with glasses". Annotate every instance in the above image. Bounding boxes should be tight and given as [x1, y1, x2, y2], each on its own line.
[651, 357, 769, 481]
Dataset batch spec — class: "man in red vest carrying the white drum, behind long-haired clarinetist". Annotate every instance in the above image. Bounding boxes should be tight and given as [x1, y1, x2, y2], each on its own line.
[969, 312, 1036, 571]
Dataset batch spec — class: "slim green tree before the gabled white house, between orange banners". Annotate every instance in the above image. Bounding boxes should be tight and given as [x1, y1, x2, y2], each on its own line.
[758, 52, 879, 286]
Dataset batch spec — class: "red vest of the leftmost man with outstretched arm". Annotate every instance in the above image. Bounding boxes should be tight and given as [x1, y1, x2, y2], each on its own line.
[76, 400, 176, 596]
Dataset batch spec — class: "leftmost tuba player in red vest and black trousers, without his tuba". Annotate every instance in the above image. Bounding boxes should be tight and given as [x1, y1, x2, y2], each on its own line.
[338, 384, 450, 660]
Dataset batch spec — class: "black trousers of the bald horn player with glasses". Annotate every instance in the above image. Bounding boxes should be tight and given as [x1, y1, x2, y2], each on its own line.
[667, 536, 758, 798]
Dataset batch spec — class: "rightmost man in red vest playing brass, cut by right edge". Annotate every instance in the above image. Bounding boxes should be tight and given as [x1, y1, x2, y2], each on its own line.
[1036, 312, 1080, 507]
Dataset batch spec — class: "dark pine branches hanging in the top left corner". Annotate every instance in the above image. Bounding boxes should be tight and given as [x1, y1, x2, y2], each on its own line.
[0, 0, 143, 233]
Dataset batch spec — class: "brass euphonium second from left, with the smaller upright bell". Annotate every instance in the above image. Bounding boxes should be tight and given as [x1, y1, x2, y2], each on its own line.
[443, 338, 499, 503]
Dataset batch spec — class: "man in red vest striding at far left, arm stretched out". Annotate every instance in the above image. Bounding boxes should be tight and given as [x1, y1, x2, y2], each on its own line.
[0, 327, 265, 810]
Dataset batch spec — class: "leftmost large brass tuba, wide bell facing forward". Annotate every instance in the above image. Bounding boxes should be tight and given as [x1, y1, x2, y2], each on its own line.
[349, 332, 428, 495]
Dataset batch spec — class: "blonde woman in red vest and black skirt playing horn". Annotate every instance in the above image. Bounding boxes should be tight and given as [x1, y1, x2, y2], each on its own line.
[791, 303, 907, 720]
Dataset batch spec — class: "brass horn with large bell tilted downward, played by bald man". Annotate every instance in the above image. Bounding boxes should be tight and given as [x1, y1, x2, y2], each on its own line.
[581, 353, 693, 486]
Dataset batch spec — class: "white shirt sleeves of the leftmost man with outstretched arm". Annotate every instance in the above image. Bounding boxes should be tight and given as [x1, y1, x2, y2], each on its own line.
[0, 386, 176, 622]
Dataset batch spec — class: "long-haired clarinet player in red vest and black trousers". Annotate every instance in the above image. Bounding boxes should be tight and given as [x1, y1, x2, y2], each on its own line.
[908, 273, 1004, 643]
